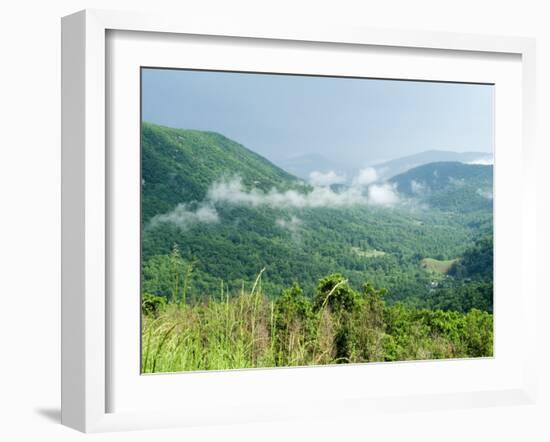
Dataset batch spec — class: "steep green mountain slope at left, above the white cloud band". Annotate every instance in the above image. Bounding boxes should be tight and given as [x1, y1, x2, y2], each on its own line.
[141, 122, 297, 221]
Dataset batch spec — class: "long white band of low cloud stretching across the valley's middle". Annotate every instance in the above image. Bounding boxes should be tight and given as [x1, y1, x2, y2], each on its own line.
[207, 177, 367, 209]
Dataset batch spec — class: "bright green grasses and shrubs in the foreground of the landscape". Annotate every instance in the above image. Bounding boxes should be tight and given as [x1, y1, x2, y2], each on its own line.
[142, 273, 493, 373]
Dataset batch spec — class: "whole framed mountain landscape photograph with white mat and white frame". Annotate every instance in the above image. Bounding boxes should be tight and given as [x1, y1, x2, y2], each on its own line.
[62, 11, 537, 432]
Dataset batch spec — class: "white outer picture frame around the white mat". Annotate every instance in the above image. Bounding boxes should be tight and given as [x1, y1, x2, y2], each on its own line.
[62, 10, 537, 432]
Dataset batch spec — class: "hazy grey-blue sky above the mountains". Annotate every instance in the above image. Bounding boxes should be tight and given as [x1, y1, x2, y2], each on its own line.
[142, 69, 494, 167]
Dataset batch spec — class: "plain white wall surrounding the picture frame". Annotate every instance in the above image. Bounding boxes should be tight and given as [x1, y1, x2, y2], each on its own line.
[0, 0, 550, 441]
